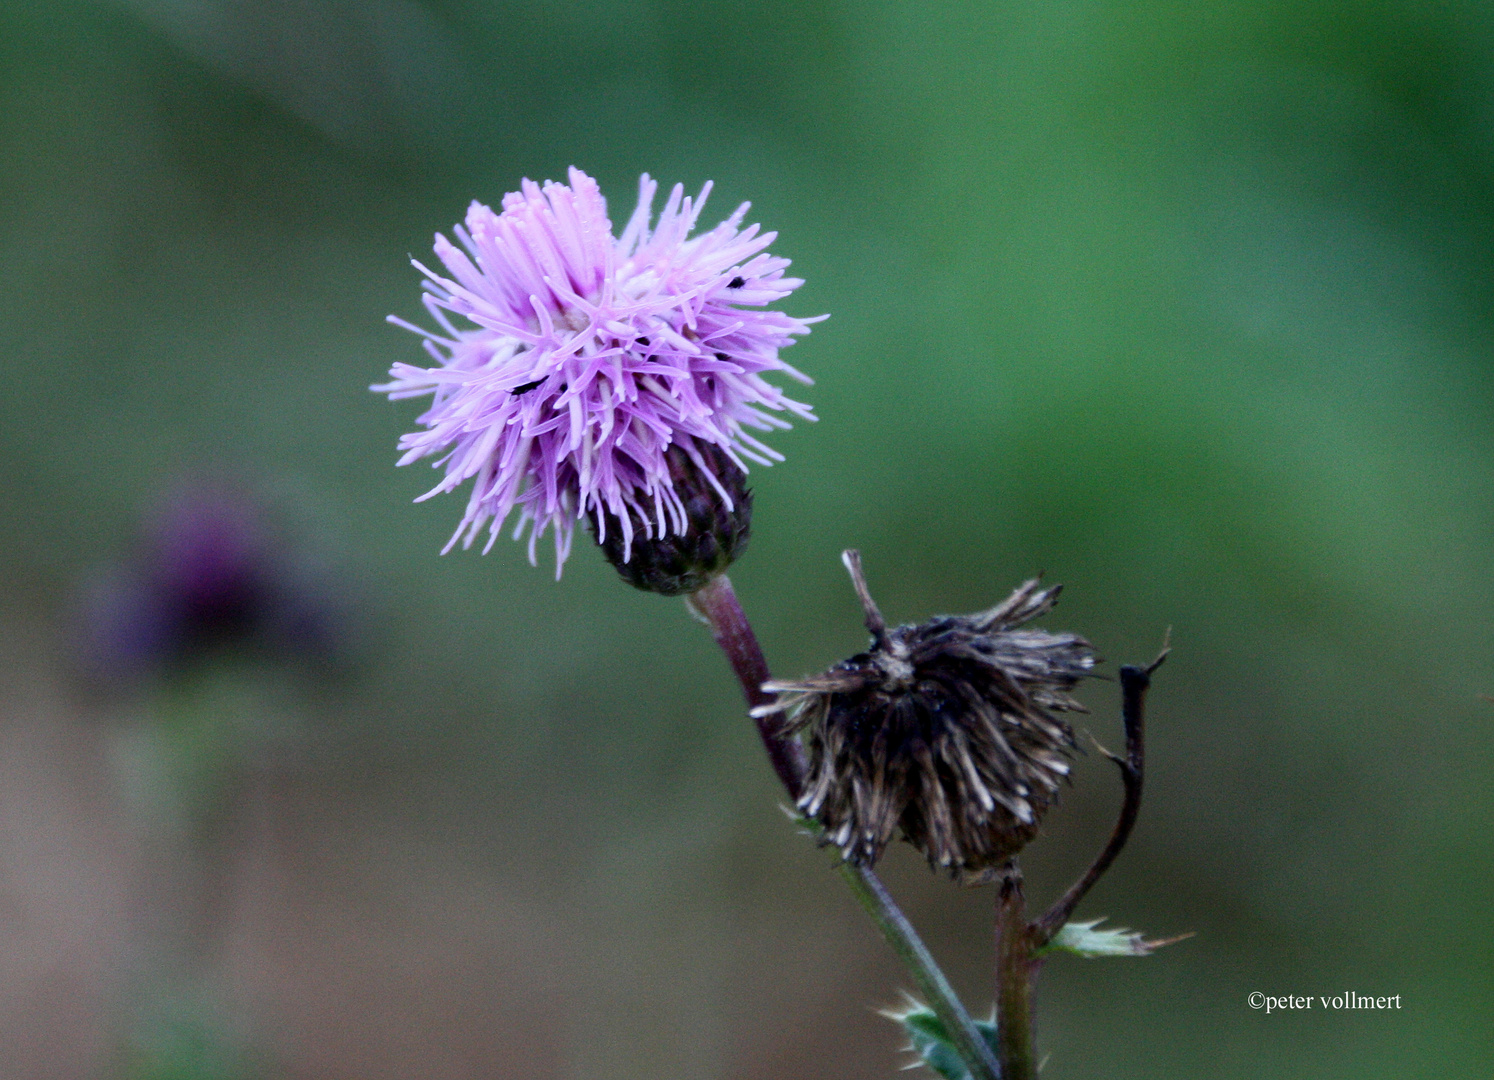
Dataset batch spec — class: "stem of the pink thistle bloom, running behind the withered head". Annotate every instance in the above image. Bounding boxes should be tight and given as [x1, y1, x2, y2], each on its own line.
[687, 574, 1003, 1080]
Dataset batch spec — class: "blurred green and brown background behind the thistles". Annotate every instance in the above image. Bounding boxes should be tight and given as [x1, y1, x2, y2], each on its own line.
[0, 0, 1494, 1080]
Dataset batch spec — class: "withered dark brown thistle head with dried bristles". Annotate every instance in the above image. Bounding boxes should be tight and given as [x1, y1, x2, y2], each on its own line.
[757, 551, 1095, 884]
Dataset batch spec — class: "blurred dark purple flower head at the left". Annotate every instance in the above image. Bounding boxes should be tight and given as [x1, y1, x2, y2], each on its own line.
[84, 485, 339, 675]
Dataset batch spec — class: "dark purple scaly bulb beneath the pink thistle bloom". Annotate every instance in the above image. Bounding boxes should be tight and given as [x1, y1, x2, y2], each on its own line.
[589, 441, 751, 596]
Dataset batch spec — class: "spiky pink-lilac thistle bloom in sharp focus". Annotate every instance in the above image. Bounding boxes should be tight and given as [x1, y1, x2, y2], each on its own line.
[372, 169, 825, 577]
